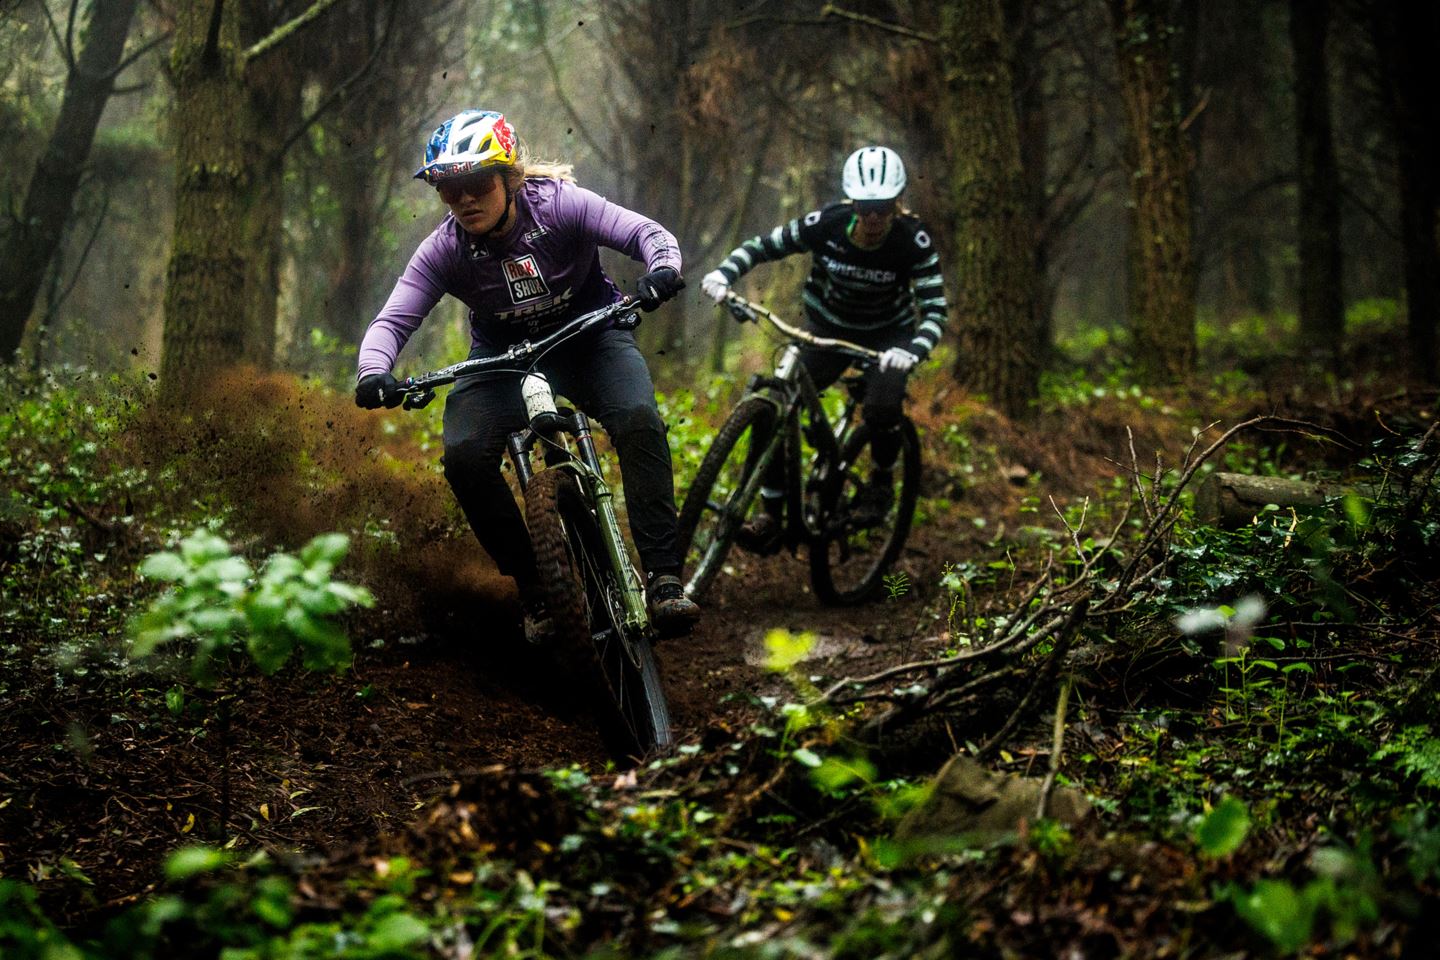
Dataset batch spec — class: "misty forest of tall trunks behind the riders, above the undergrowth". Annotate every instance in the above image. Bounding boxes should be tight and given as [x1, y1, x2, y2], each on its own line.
[0, 0, 1437, 397]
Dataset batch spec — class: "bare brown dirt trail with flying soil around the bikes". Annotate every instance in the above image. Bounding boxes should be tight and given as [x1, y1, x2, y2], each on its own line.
[8, 359, 1370, 921]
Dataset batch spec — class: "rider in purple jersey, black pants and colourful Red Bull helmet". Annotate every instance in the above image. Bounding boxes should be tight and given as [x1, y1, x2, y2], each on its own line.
[356, 109, 700, 636]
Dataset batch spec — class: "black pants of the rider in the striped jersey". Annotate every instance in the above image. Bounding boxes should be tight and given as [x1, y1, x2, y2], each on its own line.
[760, 311, 914, 511]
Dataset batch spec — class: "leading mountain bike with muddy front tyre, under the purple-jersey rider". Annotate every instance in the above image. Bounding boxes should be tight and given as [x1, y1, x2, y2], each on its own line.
[400, 298, 674, 759]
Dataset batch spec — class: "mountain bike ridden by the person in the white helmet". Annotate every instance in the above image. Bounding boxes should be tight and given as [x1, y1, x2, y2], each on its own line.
[680, 291, 920, 606]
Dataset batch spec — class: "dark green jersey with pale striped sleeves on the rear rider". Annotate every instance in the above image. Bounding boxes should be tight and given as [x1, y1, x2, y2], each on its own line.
[717, 203, 946, 357]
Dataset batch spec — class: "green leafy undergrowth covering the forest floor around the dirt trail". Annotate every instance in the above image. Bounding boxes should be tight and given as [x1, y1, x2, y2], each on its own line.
[0, 333, 1440, 960]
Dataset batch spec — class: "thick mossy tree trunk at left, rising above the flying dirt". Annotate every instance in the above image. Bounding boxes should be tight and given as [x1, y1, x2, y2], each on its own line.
[160, 0, 255, 396]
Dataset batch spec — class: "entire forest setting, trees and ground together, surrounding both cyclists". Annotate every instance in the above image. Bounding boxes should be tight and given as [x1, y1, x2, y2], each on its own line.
[0, 0, 1440, 960]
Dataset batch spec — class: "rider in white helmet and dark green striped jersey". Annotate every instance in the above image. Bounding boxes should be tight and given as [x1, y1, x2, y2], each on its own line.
[700, 147, 946, 554]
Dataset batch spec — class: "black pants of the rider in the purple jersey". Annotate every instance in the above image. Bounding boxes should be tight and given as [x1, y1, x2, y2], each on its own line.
[444, 330, 680, 584]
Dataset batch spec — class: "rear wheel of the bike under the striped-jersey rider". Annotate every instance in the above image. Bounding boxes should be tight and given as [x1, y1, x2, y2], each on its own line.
[806, 419, 920, 606]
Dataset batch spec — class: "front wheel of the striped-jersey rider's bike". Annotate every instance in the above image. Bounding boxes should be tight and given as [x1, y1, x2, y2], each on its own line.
[678, 397, 775, 597]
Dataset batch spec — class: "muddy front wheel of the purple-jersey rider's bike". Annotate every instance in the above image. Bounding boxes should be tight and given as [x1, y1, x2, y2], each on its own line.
[526, 469, 674, 760]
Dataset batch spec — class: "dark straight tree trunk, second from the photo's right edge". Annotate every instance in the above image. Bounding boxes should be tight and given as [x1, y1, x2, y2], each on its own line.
[1290, 0, 1345, 357]
